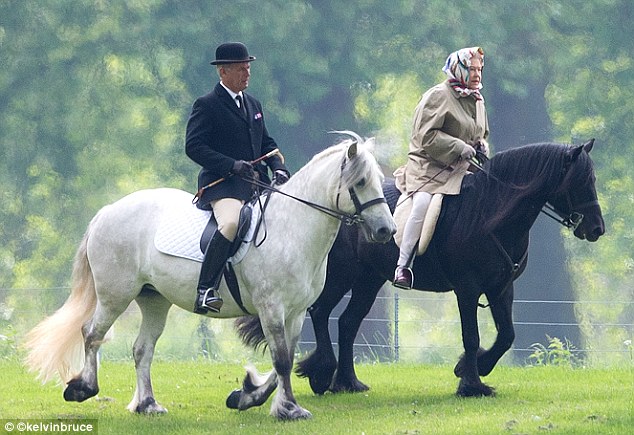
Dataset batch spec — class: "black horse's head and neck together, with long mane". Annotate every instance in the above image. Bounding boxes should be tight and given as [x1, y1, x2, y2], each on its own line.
[456, 140, 605, 242]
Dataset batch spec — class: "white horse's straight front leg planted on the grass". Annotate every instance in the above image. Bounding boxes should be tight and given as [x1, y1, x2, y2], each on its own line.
[262, 312, 312, 420]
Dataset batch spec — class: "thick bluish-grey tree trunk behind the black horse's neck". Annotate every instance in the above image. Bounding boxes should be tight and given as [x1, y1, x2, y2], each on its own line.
[486, 83, 582, 363]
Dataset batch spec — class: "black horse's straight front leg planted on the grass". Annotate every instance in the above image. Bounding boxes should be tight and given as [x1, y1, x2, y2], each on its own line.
[454, 290, 494, 397]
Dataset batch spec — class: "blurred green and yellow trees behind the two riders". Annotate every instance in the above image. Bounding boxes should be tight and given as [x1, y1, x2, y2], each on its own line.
[0, 0, 634, 364]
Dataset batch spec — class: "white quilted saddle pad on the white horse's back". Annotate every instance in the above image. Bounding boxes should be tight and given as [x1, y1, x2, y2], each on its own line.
[154, 199, 260, 264]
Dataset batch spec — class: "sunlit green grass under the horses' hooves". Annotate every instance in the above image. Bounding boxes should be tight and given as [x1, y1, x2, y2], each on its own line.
[0, 361, 634, 435]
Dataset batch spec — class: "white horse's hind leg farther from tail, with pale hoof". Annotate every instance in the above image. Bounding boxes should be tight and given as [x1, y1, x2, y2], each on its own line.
[127, 288, 172, 414]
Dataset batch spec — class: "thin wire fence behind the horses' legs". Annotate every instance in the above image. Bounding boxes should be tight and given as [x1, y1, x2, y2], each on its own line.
[0, 286, 634, 365]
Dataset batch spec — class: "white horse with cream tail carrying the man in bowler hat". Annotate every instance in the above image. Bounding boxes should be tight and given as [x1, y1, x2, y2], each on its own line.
[27, 132, 396, 419]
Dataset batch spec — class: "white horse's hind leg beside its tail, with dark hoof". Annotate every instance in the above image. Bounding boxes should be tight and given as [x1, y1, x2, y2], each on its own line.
[64, 300, 130, 402]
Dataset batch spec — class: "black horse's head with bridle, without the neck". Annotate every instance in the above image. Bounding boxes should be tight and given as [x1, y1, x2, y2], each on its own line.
[548, 139, 605, 242]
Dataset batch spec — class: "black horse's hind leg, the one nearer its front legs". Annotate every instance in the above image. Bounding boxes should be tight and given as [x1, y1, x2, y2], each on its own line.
[330, 271, 385, 393]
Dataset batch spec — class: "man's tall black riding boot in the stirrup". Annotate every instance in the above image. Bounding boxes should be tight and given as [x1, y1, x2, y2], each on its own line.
[194, 230, 232, 314]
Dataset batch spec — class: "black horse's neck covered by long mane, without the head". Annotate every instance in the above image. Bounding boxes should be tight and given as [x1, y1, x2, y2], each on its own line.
[458, 143, 569, 240]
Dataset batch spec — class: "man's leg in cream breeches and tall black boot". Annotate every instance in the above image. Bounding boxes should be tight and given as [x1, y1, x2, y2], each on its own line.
[194, 198, 243, 314]
